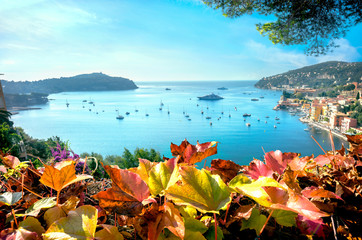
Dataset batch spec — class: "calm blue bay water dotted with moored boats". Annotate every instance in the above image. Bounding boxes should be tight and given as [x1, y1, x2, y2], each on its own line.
[12, 81, 348, 165]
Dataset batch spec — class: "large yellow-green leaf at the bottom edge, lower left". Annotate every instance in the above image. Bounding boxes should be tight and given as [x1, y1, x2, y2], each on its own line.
[43, 205, 98, 240]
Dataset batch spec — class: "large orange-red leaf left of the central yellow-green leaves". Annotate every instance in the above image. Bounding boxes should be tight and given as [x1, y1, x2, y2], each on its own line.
[93, 166, 150, 215]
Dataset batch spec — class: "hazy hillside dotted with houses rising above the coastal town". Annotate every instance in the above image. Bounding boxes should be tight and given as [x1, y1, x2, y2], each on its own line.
[255, 61, 362, 89]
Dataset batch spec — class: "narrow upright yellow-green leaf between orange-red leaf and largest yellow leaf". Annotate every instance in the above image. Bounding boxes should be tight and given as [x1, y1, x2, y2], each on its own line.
[148, 158, 177, 196]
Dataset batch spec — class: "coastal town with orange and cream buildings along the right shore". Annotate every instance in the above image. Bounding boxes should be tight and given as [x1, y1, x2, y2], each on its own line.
[274, 82, 362, 138]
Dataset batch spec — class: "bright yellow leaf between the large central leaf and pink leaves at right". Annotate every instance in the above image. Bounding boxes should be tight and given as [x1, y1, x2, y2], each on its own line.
[232, 177, 284, 207]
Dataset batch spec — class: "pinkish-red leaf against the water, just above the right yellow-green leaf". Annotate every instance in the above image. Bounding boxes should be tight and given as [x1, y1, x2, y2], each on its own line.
[265, 150, 298, 175]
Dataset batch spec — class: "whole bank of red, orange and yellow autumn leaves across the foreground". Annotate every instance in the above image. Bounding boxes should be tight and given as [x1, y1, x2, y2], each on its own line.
[0, 136, 362, 240]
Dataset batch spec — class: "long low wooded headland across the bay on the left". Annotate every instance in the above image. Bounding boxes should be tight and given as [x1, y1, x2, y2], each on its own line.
[1, 73, 138, 94]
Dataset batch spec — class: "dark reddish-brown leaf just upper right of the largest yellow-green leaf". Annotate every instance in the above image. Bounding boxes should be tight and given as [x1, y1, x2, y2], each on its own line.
[211, 159, 242, 183]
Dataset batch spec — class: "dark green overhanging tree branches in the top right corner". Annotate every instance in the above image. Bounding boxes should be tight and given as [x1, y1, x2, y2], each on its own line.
[203, 0, 362, 55]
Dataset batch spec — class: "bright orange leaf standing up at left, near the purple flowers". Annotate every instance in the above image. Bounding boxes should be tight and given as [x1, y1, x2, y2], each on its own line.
[40, 161, 93, 192]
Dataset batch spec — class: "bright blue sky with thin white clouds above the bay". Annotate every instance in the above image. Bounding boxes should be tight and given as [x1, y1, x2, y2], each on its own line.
[0, 0, 362, 81]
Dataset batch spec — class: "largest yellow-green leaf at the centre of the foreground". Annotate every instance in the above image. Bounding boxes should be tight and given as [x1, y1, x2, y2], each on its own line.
[166, 166, 231, 213]
